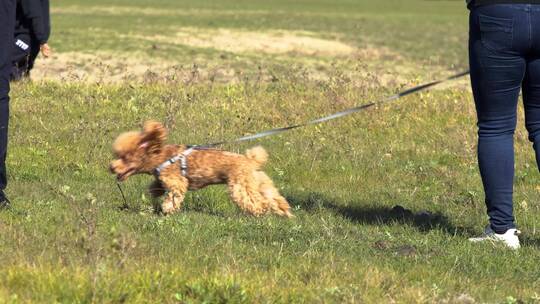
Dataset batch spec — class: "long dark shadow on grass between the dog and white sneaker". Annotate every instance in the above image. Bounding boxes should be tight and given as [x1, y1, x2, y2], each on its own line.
[287, 193, 478, 237]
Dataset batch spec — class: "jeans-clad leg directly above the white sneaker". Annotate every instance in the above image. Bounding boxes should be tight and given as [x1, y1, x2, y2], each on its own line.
[469, 5, 529, 234]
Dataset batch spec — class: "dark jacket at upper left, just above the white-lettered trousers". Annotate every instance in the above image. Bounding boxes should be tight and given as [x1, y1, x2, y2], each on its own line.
[15, 0, 51, 44]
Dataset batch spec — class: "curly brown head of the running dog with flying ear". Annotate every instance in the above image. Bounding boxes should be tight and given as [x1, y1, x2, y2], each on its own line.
[109, 121, 167, 181]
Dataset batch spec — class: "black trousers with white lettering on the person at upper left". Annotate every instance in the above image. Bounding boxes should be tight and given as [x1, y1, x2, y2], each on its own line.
[11, 34, 40, 80]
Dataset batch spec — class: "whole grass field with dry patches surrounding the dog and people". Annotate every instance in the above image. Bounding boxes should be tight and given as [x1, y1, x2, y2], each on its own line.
[0, 0, 540, 303]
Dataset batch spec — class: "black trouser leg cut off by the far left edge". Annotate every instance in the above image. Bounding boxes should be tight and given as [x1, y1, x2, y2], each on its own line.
[0, 0, 15, 191]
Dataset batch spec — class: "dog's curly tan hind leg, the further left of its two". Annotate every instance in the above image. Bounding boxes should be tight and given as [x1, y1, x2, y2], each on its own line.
[228, 172, 268, 216]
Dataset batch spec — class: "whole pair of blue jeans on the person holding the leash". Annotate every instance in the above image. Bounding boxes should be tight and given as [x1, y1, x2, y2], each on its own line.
[469, 4, 540, 233]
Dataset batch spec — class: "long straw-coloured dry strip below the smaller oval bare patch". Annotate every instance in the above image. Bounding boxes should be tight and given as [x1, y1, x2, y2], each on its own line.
[28, 49, 456, 89]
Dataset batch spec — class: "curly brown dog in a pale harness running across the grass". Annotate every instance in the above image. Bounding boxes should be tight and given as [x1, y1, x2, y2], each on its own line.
[110, 121, 292, 217]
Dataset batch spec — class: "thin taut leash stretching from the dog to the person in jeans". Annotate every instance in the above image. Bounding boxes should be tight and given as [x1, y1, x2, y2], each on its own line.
[197, 70, 470, 149]
